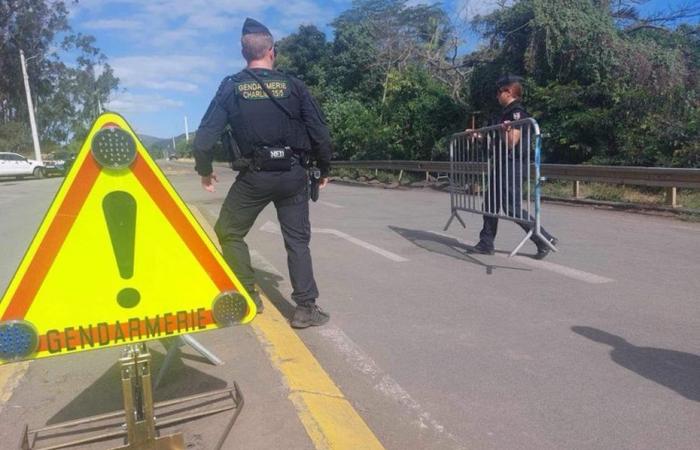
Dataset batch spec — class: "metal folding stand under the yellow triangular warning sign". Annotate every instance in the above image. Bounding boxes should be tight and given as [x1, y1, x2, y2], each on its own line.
[19, 341, 244, 450]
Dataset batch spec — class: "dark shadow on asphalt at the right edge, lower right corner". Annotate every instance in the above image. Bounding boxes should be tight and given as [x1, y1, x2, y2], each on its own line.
[571, 326, 700, 402]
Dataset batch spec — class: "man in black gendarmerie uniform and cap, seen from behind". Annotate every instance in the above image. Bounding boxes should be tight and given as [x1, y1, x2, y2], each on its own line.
[194, 18, 331, 328]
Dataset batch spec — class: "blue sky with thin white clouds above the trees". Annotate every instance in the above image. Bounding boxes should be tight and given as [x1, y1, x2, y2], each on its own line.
[64, 0, 687, 138]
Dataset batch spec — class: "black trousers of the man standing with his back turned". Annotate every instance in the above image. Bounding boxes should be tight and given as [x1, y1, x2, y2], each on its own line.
[214, 163, 318, 305]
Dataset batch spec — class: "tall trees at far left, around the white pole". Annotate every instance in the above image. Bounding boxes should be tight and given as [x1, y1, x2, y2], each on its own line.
[0, 0, 118, 153]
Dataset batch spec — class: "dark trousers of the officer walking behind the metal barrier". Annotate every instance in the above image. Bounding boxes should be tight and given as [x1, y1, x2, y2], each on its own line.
[479, 158, 552, 248]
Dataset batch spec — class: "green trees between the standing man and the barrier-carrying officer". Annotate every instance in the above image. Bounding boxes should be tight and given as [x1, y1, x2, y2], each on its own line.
[278, 0, 466, 159]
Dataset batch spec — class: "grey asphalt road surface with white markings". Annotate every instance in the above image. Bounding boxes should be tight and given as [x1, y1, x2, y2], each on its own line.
[0, 163, 700, 449]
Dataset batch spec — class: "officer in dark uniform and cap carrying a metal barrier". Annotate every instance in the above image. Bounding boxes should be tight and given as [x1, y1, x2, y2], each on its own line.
[467, 75, 558, 259]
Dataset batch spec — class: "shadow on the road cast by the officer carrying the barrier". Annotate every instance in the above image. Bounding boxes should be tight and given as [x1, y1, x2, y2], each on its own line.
[389, 225, 531, 275]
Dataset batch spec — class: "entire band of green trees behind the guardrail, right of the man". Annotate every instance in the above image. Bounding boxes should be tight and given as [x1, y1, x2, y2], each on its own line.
[278, 0, 700, 167]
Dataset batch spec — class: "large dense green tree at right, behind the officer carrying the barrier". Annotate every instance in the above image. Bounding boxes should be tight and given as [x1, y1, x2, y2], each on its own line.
[465, 0, 699, 165]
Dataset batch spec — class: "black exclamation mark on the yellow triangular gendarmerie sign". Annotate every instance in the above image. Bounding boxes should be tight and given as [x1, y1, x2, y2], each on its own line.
[102, 191, 141, 308]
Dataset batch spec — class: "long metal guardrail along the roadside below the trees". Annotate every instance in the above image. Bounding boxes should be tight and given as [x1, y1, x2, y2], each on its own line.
[333, 160, 700, 208]
